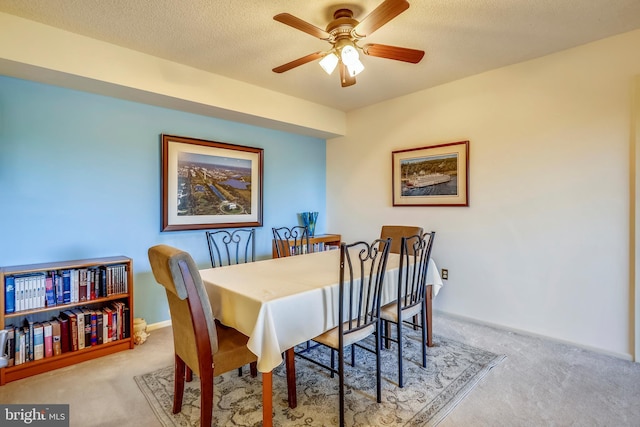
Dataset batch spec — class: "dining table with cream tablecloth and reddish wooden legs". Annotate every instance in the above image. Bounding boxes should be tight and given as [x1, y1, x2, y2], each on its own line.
[200, 250, 442, 427]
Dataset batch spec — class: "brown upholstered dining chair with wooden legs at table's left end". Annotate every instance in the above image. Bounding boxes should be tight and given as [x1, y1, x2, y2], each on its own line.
[149, 245, 257, 426]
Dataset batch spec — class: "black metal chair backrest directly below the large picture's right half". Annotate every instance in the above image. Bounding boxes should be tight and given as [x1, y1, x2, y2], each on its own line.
[207, 228, 256, 267]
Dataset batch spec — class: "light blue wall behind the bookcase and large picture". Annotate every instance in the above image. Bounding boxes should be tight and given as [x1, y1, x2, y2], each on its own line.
[0, 76, 326, 323]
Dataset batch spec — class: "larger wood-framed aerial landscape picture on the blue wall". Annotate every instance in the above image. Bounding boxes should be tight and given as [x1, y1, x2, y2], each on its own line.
[162, 135, 263, 231]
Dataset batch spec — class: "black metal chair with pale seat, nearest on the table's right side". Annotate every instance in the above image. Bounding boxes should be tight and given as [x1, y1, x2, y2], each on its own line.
[296, 239, 391, 426]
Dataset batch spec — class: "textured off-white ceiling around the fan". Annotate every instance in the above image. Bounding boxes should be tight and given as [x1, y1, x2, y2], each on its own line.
[0, 0, 640, 111]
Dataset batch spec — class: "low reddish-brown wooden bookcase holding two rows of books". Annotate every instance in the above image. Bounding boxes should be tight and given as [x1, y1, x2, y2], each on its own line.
[0, 256, 134, 385]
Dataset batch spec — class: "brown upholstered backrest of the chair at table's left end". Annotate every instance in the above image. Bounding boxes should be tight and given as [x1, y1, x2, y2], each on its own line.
[148, 245, 218, 375]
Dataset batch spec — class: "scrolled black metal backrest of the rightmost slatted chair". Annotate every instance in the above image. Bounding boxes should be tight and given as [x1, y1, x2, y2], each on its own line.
[398, 231, 436, 310]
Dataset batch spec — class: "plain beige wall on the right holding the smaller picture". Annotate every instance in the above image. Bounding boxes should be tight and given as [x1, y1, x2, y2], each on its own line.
[327, 27, 640, 358]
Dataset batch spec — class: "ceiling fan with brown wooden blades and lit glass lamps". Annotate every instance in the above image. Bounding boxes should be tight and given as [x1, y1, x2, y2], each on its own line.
[273, 0, 424, 87]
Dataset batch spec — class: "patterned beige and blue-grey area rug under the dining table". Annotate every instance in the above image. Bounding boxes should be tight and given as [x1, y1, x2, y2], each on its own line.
[135, 328, 505, 427]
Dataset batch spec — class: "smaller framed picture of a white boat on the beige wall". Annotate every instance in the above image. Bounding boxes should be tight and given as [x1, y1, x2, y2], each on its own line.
[391, 141, 469, 206]
